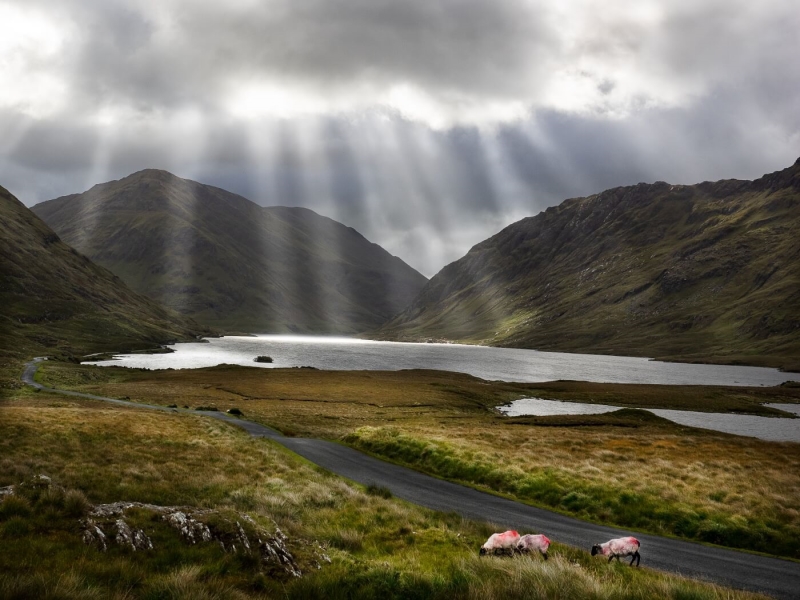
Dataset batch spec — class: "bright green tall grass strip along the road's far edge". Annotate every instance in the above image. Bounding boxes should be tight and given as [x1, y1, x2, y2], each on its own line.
[344, 427, 800, 558]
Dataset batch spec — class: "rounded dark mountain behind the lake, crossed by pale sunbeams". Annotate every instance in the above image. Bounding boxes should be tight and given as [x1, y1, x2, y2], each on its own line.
[32, 169, 427, 333]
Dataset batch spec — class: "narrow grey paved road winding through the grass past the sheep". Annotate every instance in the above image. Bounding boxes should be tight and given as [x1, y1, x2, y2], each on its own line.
[22, 358, 800, 599]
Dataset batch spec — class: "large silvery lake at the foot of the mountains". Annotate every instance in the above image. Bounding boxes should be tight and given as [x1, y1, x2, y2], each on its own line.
[88, 335, 800, 386]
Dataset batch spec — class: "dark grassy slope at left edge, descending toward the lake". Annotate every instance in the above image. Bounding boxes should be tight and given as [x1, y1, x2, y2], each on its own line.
[0, 187, 209, 360]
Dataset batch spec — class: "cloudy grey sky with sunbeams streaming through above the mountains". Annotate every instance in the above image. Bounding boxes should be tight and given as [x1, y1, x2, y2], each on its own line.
[0, 0, 800, 276]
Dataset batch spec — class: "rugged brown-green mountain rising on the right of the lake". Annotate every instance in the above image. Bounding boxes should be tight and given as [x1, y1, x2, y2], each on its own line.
[377, 160, 800, 368]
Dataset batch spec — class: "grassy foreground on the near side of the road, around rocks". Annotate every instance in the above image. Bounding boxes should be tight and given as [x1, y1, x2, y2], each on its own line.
[0, 390, 768, 600]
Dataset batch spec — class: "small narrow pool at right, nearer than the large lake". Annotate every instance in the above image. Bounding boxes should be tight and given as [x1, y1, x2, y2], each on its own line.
[498, 398, 800, 442]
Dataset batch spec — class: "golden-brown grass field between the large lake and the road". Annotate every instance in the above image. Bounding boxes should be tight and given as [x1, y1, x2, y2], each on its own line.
[28, 364, 800, 558]
